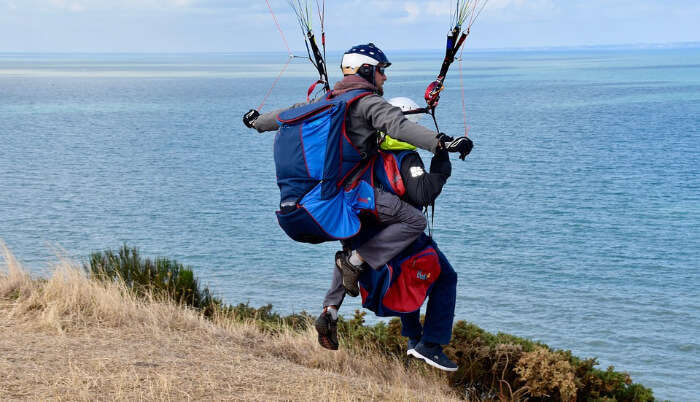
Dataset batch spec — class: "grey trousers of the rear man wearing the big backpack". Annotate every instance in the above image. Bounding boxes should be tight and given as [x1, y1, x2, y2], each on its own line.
[323, 188, 428, 307]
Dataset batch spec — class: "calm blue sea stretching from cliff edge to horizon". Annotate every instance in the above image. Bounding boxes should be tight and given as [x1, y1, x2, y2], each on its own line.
[0, 49, 700, 401]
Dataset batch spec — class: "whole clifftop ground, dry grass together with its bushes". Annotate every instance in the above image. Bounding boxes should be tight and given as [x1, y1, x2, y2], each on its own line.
[0, 244, 654, 401]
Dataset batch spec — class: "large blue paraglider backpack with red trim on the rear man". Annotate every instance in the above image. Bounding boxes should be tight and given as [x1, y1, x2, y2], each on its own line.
[274, 90, 375, 244]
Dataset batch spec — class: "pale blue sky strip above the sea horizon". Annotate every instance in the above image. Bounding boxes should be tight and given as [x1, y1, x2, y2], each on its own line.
[0, 0, 700, 52]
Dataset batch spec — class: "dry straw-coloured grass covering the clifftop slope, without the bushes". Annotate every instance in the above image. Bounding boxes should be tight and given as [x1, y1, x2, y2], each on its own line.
[0, 244, 458, 401]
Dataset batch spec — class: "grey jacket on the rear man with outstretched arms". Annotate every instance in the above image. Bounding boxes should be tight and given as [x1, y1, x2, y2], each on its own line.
[253, 88, 438, 156]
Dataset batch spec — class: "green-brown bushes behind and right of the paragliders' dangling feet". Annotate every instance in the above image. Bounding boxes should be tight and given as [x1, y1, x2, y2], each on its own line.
[338, 316, 654, 402]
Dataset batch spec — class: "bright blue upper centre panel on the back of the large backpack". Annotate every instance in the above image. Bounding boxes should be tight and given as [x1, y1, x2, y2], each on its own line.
[301, 108, 334, 180]
